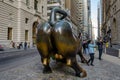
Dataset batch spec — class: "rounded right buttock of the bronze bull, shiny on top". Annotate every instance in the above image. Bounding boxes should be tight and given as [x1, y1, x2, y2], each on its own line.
[53, 21, 78, 56]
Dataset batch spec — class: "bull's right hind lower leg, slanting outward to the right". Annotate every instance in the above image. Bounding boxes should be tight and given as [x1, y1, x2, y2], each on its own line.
[70, 59, 87, 77]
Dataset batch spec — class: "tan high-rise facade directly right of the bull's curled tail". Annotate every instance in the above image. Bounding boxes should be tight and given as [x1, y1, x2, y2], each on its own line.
[70, 0, 84, 33]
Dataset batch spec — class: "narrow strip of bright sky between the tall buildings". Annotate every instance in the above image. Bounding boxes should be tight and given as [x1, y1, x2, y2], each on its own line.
[91, 0, 100, 39]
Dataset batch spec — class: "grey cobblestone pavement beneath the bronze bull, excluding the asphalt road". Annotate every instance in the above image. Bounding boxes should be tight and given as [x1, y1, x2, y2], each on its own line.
[0, 52, 120, 80]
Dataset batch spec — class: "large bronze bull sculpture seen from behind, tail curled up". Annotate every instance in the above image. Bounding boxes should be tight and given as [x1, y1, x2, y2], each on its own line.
[37, 8, 87, 77]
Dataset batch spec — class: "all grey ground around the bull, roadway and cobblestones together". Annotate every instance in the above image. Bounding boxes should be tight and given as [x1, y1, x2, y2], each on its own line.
[0, 50, 120, 80]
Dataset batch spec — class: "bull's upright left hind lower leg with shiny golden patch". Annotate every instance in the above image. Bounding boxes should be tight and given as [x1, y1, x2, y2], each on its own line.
[41, 58, 52, 73]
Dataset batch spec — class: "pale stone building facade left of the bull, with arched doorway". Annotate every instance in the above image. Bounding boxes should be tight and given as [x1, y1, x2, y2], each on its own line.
[0, 0, 42, 47]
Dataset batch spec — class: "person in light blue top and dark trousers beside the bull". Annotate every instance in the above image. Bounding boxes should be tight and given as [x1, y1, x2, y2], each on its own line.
[88, 40, 95, 66]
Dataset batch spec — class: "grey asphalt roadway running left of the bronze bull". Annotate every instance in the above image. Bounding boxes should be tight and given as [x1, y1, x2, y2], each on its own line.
[0, 50, 39, 72]
